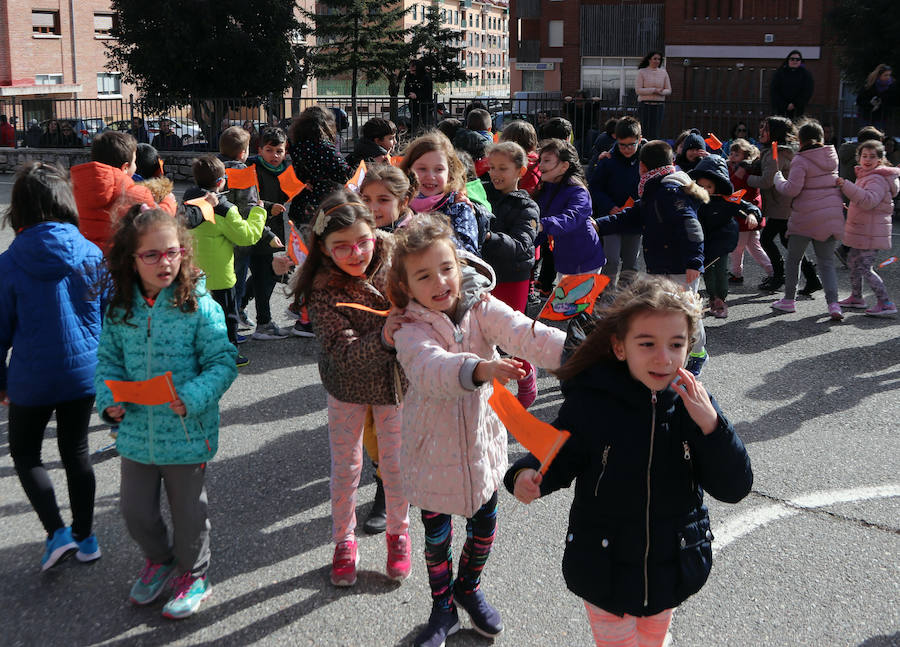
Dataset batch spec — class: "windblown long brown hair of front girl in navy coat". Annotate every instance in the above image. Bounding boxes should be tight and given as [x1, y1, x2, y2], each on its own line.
[556, 275, 702, 380]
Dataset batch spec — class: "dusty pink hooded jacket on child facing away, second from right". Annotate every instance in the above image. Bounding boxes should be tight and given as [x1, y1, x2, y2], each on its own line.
[774, 144, 844, 240]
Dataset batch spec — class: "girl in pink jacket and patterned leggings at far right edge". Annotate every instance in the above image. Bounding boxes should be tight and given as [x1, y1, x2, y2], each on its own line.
[836, 141, 900, 317]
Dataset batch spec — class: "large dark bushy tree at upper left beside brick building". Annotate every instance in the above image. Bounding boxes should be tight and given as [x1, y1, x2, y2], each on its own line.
[106, 0, 300, 136]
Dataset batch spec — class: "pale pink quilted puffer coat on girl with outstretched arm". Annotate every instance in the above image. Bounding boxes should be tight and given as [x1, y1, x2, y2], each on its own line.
[394, 252, 566, 517]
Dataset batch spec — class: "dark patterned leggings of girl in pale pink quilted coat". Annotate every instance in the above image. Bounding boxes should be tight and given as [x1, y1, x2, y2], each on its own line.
[422, 492, 497, 609]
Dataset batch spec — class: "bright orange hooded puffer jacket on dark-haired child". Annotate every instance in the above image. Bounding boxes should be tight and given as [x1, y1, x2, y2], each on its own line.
[70, 162, 176, 251]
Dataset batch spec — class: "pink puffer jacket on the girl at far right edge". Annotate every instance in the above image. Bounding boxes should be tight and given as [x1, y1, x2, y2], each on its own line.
[842, 166, 900, 249]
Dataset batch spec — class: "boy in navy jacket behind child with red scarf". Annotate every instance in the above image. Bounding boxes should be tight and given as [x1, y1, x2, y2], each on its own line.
[589, 117, 641, 288]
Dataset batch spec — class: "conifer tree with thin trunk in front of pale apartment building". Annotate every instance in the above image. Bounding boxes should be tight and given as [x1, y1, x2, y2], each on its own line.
[301, 0, 408, 133]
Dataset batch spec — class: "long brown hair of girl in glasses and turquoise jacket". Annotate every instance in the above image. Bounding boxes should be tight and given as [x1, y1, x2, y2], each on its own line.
[106, 204, 200, 326]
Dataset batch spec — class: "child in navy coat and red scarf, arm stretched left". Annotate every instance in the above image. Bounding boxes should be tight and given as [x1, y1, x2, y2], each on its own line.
[596, 139, 711, 375]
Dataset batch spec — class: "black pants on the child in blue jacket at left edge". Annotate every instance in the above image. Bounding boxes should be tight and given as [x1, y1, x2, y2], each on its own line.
[9, 395, 96, 540]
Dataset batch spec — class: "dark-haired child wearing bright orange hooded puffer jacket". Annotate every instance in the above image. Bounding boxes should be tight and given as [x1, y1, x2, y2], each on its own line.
[72, 130, 176, 250]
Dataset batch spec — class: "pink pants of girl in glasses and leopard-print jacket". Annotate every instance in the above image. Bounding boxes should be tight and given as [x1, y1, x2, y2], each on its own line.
[328, 395, 409, 543]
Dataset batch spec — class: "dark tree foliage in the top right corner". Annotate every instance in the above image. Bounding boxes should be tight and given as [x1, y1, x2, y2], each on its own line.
[825, 0, 900, 88]
